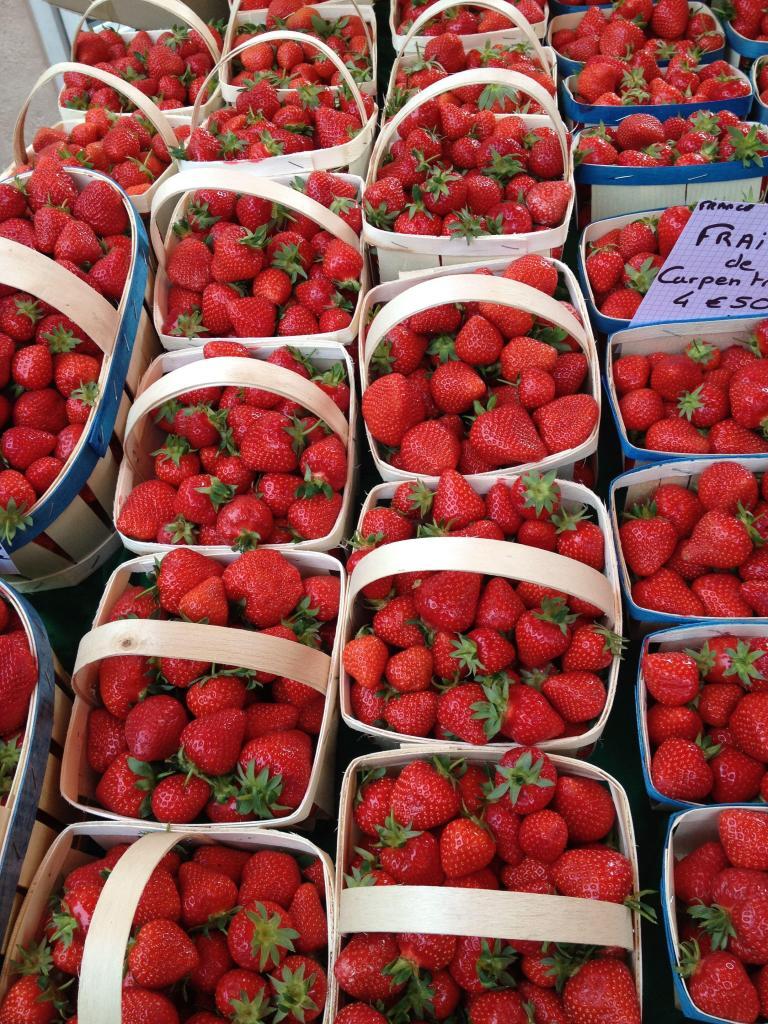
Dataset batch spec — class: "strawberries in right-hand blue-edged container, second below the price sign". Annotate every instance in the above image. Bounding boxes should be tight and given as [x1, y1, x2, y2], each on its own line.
[618, 462, 768, 618]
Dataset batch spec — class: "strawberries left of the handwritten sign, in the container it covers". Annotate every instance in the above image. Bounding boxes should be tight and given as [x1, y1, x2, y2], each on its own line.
[584, 203, 691, 323]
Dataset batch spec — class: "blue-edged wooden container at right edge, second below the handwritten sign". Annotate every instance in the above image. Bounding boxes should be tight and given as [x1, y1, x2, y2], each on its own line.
[608, 456, 768, 634]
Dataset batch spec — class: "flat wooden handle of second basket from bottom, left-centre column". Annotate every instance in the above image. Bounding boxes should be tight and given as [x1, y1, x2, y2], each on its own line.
[72, 618, 331, 699]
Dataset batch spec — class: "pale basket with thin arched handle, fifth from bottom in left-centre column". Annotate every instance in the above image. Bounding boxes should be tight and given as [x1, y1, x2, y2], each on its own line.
[179, 29, 377, 177]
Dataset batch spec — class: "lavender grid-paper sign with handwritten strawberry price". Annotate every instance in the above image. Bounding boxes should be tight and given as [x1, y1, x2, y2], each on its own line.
[632, 200, 768, 327]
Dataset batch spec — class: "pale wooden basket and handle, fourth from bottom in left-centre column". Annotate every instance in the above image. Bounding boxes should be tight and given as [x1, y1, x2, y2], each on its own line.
[150, 163, 369, 349]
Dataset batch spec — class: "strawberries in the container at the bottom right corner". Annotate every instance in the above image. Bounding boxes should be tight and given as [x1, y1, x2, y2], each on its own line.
[674, 807, 768, 1024]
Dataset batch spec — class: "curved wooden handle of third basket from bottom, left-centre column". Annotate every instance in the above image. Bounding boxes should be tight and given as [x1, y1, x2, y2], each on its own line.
[124, 355, 349, 447]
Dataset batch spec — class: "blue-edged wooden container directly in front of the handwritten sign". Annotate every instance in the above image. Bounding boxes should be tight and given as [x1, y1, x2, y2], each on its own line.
[603, 316, 768, 465]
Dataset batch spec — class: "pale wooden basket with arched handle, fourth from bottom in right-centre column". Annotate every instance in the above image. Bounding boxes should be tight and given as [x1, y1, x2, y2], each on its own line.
[362, 68, 574, 282]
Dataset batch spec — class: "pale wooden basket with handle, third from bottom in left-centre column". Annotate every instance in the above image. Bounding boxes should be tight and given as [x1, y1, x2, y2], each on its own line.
[114, 343, 357, 557]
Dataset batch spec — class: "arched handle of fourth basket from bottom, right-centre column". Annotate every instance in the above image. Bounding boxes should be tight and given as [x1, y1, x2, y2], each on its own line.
[369, 68, 570, 181]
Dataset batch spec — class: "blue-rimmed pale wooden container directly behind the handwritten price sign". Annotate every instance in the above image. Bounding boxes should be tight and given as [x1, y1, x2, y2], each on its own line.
[573, 125, 768, 221]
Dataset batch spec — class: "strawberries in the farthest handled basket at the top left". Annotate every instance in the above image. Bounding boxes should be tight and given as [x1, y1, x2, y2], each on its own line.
[58, 25, 221, 113]
